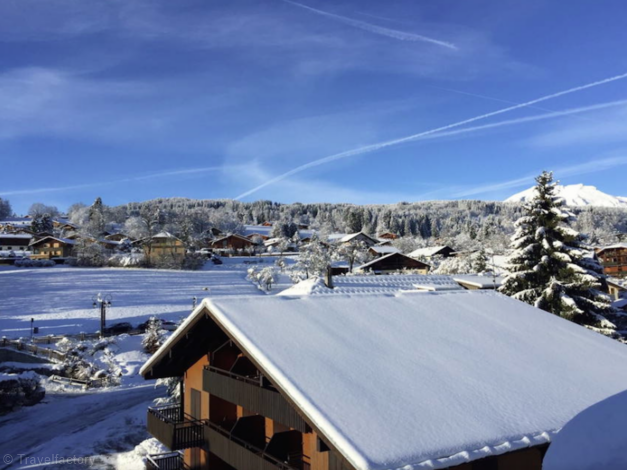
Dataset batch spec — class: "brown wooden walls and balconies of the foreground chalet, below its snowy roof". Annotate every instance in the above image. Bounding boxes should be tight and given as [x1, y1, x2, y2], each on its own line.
[142, 307, 547, 470]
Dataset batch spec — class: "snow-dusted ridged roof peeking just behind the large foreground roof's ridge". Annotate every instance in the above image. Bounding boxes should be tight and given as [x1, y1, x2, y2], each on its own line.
[277, 274, 462, 296]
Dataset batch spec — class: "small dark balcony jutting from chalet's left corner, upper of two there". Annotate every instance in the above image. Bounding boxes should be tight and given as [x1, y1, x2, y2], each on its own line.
[148, 405, 205, 451]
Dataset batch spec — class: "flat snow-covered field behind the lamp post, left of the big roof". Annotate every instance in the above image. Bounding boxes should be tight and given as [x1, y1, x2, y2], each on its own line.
[0, 257, 289, 337]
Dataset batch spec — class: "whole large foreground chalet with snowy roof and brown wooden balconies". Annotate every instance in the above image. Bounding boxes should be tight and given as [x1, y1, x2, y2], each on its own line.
[140, 290, 627, 470]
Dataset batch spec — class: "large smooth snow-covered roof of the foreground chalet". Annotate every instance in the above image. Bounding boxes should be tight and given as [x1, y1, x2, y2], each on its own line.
[195, 292, 627, 470]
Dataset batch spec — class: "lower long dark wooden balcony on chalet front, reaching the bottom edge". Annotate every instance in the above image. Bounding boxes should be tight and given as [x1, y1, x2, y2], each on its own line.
[205, 421, 308, 470]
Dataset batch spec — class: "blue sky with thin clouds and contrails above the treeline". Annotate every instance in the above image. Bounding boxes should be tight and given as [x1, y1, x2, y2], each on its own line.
[0, 0, 627, 212]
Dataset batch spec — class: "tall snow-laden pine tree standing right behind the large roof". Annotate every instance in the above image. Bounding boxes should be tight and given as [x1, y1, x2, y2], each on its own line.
[500, 172, 613, 326]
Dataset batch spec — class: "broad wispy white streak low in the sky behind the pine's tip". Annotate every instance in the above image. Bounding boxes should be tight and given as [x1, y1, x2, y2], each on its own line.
[452, 157, 627, 197]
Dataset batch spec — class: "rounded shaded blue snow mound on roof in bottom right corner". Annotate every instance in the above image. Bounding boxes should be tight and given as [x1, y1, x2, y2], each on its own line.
[542, 391, 627, 470]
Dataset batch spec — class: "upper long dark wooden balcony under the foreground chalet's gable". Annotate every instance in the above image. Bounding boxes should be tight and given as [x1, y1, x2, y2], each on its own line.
[203, 366, 308, 432]
